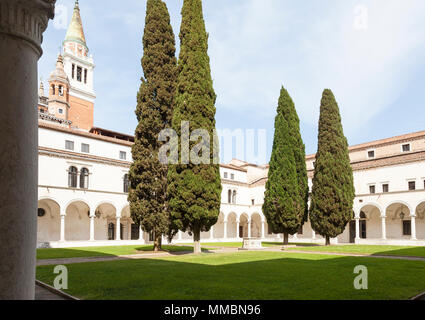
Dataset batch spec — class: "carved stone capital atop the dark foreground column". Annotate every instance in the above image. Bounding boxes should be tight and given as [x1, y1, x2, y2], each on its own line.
[0, 0, 56, 56]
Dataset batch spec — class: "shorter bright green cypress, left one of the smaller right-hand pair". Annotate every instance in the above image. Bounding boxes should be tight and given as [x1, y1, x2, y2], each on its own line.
[263, 87, 308, 245]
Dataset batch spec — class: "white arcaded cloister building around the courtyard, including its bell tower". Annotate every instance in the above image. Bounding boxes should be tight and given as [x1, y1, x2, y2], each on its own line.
[38, 0, 425, 247]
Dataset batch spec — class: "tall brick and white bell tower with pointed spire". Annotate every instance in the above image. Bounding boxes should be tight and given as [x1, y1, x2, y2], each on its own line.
[63, 0, 96, 130]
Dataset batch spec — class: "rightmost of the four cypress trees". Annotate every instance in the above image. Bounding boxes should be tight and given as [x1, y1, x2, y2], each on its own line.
[310, 89, 355, 245]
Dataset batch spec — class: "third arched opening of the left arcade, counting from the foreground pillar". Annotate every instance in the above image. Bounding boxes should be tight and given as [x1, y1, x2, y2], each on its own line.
[94, 203, 117, 240]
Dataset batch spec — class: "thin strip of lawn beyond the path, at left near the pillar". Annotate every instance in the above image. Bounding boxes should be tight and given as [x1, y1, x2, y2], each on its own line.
[37, 245, 212, 260]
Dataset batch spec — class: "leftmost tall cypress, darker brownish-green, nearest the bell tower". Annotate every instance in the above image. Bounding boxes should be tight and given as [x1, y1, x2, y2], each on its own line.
[128, 0, 177, 251]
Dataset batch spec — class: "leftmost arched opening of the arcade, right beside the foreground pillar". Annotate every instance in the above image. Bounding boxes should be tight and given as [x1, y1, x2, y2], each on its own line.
[37, 199, 61, 242]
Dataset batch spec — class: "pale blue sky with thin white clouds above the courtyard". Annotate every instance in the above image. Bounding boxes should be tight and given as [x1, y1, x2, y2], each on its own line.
[39, 0, 425, 164]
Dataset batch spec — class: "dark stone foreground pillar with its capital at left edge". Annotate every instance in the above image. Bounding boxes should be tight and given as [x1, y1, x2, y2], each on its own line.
[0, 0, 55, 300]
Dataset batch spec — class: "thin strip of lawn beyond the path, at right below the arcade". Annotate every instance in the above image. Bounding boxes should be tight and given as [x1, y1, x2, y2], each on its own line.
[285, 245, 425, 257]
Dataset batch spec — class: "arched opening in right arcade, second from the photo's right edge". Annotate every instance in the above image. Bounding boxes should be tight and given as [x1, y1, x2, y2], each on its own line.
[386, 203, 412, 239]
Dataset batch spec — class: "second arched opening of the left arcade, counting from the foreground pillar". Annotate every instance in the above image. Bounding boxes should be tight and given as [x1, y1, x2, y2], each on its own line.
[65, 200, 90, 241]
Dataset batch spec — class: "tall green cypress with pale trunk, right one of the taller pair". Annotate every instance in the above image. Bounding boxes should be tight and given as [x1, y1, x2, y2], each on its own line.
[168, 0, 222, 253]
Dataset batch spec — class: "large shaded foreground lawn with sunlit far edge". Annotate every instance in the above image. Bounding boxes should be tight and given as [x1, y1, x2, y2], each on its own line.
[37, 252, 425, 300]
